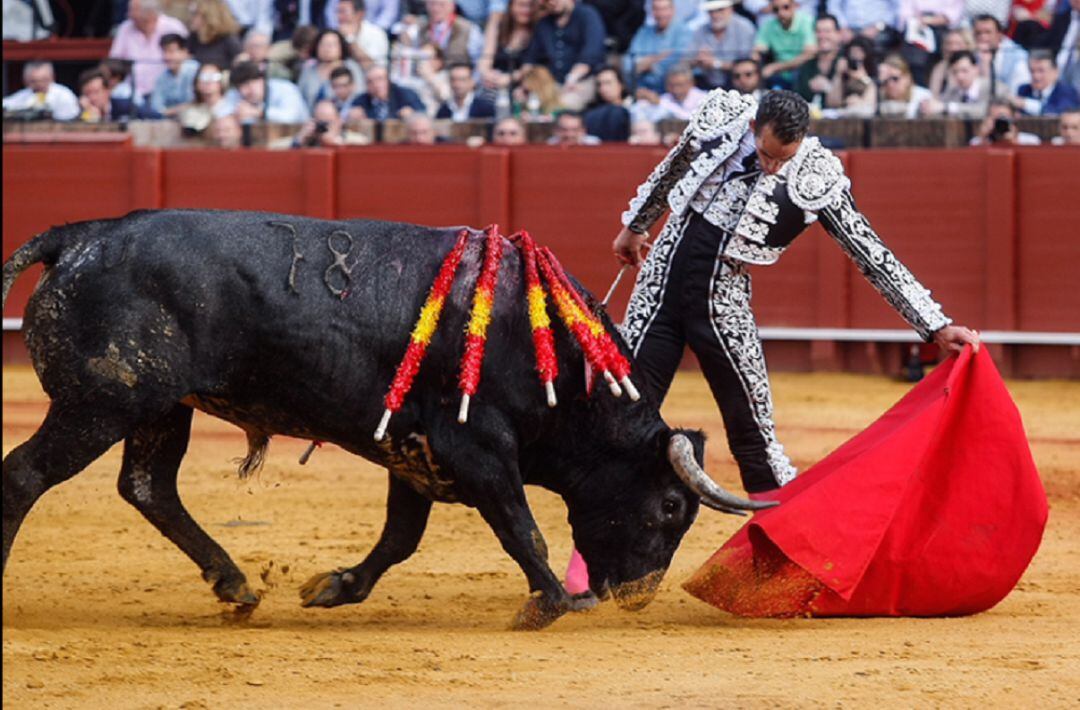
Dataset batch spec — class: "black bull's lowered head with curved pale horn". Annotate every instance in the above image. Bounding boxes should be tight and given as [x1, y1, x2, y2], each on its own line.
[567, 429, 775, 611]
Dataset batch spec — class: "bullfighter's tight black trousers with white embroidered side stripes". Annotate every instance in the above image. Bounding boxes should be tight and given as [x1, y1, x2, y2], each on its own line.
[623, 211, 795, 493]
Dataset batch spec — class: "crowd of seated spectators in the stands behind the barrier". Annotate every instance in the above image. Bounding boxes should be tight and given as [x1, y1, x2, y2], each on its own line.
[3, 0, 1080, 145]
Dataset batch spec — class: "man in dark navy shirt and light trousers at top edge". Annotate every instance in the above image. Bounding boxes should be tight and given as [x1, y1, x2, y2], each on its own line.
[524, 0, 604, 110]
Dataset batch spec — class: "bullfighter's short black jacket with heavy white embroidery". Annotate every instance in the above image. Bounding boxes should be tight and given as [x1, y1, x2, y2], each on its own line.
[622, 90, 951, 340]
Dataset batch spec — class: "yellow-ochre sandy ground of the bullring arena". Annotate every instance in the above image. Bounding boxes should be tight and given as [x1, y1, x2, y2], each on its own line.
[3, 367, 1080, 709]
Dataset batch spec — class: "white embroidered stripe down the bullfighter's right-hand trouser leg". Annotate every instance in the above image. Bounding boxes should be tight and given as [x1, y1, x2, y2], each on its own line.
[710, 259, 797, 485]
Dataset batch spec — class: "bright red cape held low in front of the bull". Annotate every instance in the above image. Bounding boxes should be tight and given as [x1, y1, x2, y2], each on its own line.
[684, 348, 1048, 616]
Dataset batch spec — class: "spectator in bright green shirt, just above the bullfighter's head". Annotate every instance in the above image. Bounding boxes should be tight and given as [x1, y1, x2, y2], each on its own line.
[754, 0, 818, 89]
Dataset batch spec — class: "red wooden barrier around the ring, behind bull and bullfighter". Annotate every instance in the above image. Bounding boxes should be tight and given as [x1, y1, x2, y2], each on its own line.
[3, 145, 1080, 375]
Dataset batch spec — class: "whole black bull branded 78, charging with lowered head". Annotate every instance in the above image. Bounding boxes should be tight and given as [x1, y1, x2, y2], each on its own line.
[3, 211, 773, 628]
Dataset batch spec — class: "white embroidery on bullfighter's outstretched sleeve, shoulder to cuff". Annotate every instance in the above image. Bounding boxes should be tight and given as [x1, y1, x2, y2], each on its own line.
[821, 190, 953, 340]
